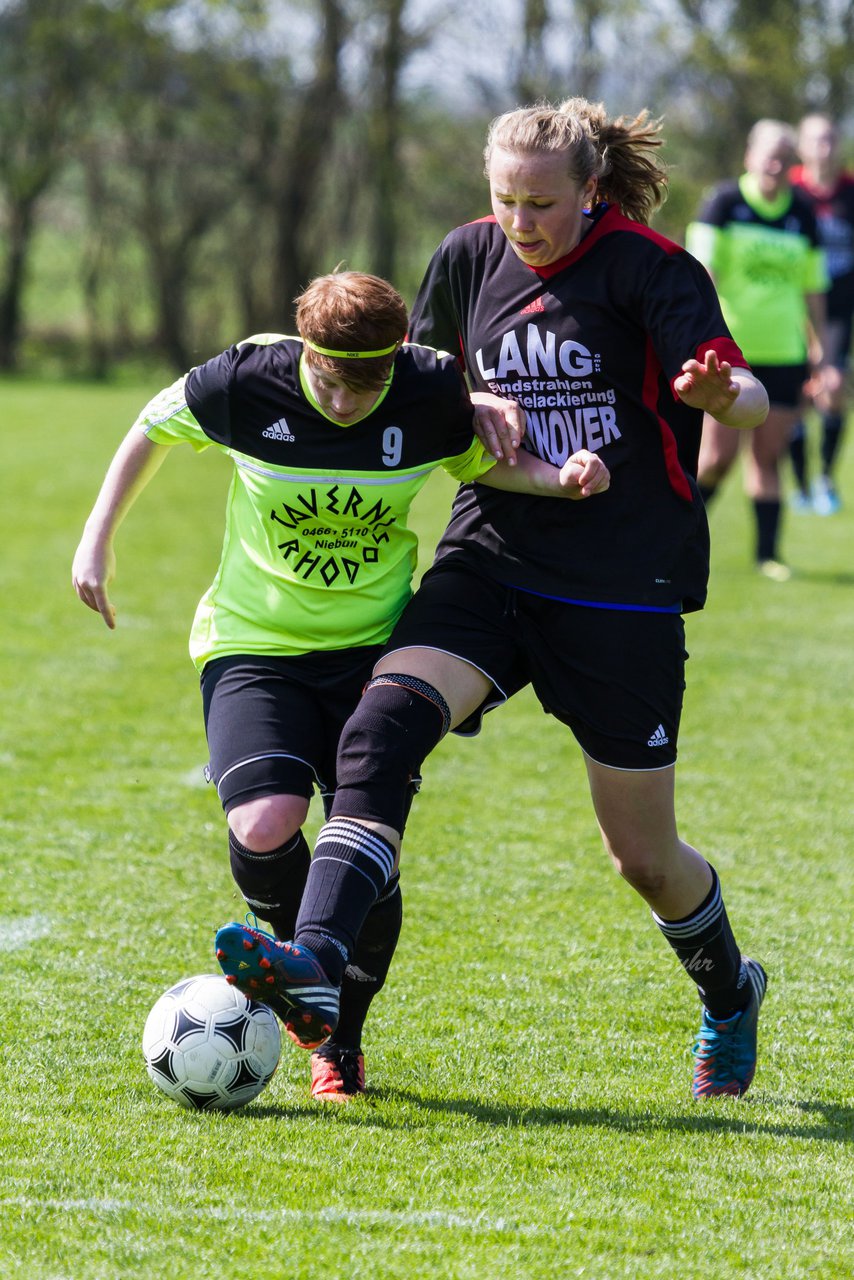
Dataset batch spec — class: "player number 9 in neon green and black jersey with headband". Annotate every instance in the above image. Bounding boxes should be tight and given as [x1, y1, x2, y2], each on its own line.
[72, 271, 608, 1100]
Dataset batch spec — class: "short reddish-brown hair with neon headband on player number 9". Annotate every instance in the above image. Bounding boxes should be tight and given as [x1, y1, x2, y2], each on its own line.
[294, 271, 408, 390]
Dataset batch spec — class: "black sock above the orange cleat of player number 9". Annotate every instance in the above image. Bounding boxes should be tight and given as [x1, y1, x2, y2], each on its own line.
[329, 873, 403, 1050]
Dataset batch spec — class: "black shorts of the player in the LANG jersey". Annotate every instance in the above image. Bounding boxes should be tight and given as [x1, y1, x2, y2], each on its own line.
[385, 559, 688, 771]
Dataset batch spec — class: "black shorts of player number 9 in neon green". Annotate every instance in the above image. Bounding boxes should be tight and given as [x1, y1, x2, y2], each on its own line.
[201, 645, 382, 813]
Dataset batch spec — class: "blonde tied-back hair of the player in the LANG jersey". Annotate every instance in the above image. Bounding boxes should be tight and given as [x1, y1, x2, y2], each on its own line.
[484, 97, 667, 223]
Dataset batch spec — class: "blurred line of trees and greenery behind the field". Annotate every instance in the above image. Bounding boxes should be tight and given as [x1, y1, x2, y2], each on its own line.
[0, 0, 854, 376]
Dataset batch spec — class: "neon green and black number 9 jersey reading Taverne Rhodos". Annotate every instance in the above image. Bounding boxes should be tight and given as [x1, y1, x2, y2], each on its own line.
[137, 334, 494, 669]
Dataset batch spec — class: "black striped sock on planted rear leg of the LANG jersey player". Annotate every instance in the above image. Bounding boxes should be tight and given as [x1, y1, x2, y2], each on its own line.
[653, 867, 750, 1019]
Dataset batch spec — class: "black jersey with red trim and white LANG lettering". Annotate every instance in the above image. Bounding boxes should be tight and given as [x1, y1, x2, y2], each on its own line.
[411, 206, 748, 611]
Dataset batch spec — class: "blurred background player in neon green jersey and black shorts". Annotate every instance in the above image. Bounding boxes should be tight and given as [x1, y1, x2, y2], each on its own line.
[686, 119, 830, 581]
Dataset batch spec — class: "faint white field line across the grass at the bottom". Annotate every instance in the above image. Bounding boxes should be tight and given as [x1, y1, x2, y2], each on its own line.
[0, 1196, 539, 1235]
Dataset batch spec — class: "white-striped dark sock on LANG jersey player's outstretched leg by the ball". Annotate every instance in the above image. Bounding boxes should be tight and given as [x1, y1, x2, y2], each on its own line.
[294, 818, 394, 984]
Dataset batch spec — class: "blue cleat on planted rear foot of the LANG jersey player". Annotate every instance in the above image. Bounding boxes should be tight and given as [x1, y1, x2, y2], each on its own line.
[691, 957, 768, 1098]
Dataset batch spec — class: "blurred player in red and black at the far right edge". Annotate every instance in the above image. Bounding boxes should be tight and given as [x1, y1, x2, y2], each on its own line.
[789, 113, 854, 516]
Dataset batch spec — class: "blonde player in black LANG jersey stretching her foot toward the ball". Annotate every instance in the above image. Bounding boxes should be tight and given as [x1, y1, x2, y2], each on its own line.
[216, 100, 768, 1097]
